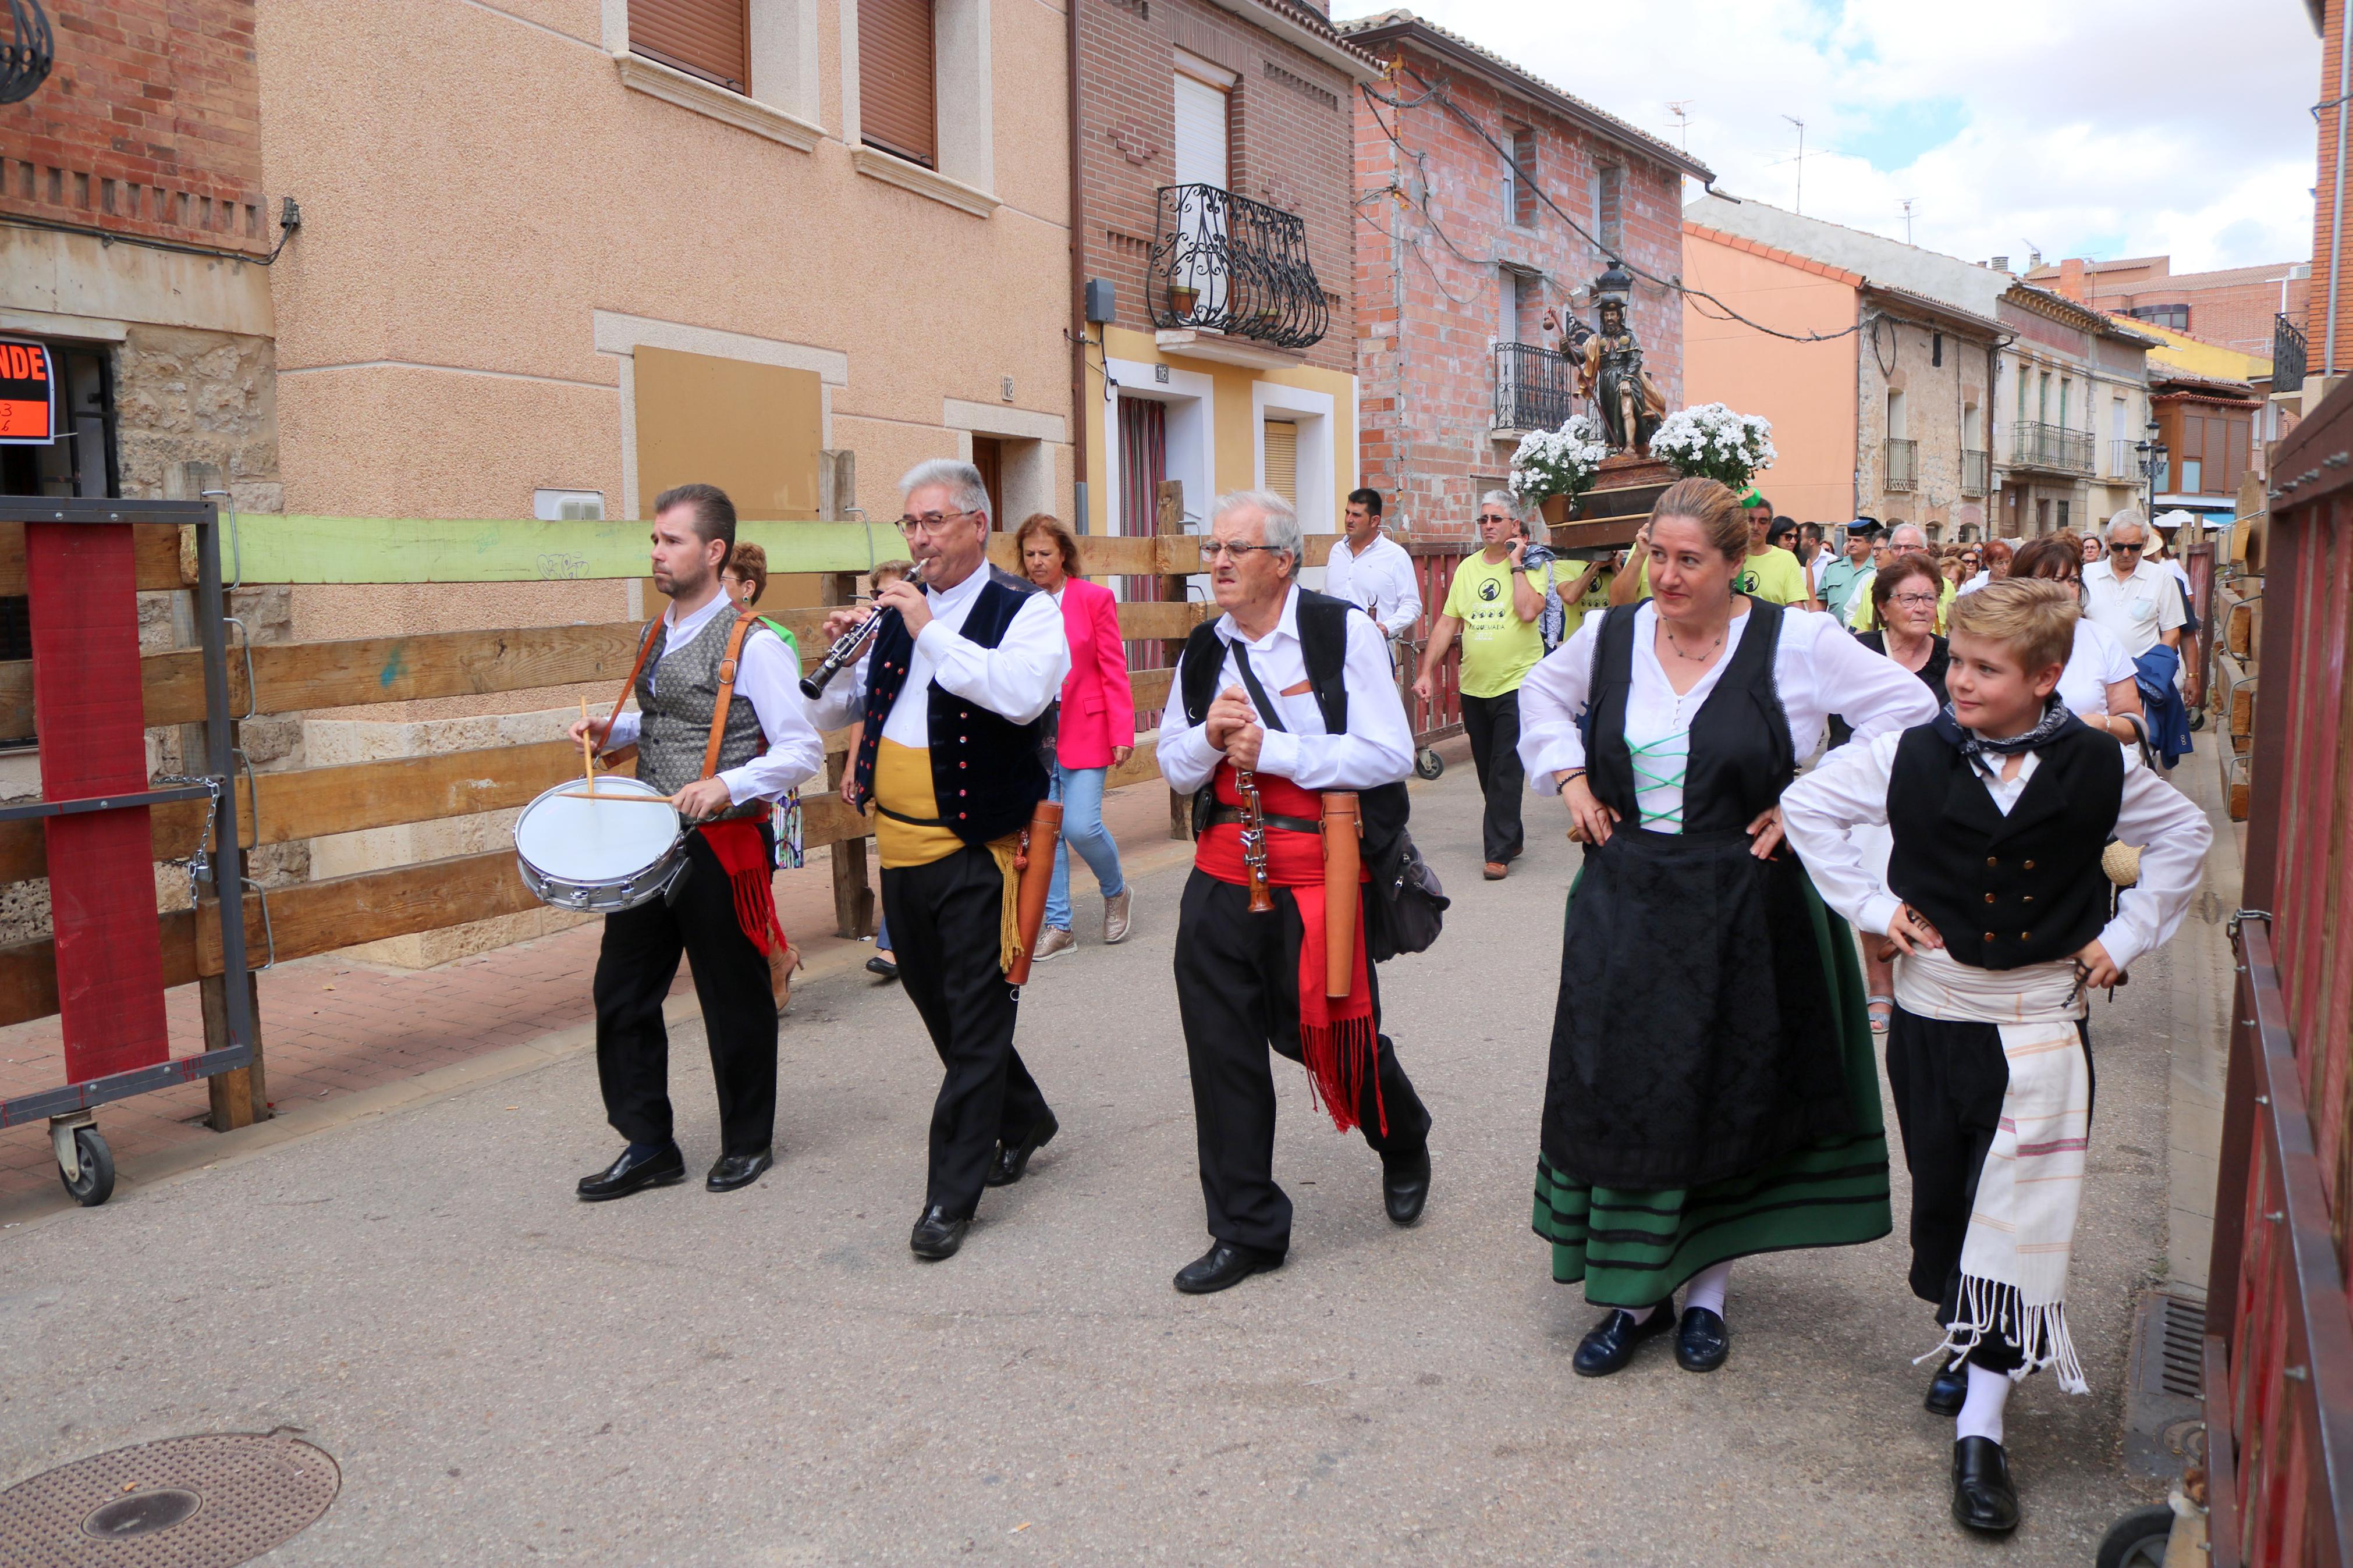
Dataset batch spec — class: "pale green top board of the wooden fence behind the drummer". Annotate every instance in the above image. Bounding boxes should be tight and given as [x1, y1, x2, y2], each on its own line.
[223, 513, 906, 583]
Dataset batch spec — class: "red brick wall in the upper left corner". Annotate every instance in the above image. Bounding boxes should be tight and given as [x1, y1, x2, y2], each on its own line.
[0, 0, 275, 251]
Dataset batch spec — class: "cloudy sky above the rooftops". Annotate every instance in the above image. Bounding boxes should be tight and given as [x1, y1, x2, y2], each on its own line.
[1332, 0, 2334, 273]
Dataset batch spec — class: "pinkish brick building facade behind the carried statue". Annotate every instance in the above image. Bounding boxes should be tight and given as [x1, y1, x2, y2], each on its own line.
[1344, 9, 1713, 536]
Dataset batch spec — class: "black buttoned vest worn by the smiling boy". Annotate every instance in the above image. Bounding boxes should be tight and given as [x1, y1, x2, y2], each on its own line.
[1887, 714, 2125, 969]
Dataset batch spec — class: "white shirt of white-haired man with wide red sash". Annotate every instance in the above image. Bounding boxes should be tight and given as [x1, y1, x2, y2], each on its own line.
[1160, 583, 1414, 795]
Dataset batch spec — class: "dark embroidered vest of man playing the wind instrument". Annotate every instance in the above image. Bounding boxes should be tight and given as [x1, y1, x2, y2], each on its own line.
[854, 567, 1059, 844]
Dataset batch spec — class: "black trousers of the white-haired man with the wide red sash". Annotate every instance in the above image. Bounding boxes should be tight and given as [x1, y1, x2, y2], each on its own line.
[1177, 870, 1431, 1253]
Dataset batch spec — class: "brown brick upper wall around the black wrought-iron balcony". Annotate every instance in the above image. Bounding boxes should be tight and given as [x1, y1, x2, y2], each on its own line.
[1073, 0, 1355, 371]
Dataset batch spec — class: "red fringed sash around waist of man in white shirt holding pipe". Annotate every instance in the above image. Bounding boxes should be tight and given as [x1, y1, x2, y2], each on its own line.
[1193, 762, 1388, 1133]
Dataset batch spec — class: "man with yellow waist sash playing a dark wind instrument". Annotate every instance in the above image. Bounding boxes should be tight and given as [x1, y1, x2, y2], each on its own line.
[812, 458, 1071, 1263]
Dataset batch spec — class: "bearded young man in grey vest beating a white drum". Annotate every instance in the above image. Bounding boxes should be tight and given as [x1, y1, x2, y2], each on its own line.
[572, 484, 826, 1204]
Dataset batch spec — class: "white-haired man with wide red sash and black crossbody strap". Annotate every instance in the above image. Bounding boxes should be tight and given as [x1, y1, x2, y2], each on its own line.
[1160, 491, 1431, 1295]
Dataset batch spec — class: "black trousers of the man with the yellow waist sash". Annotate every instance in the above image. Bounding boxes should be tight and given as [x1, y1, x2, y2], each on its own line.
[882, 847, 1047, 1215]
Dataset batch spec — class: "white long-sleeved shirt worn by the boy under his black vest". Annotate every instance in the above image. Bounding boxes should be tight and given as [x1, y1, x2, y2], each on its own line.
[1781, 736, 2214, 969]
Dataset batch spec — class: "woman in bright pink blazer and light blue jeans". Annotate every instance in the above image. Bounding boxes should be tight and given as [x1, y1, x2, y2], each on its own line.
[1014, 513, 1137, 959]
